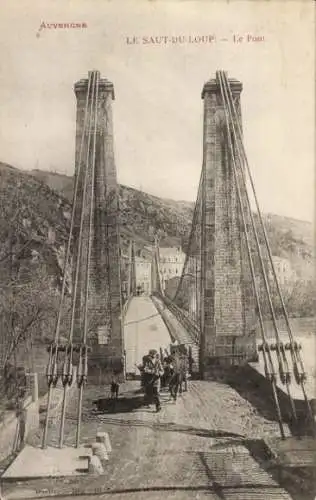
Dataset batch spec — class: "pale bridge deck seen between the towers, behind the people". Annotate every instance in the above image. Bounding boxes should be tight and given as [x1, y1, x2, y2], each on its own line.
[124, 296, 170, 374]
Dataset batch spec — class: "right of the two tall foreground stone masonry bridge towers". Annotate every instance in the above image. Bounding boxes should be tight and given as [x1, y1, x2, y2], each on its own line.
[200, 71, 256, 375]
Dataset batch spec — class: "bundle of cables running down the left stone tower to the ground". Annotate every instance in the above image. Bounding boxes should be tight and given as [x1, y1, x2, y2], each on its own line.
[42, 72, 99, 448]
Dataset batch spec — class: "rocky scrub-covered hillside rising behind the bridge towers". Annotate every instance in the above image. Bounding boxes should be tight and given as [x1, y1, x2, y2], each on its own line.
[0, 163, 314, 362]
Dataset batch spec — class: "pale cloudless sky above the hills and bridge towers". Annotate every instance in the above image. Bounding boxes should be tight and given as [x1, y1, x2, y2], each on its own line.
[0, 0, 315, 220]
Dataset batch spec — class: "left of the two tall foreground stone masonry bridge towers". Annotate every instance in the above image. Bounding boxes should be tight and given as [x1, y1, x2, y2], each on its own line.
[73, 71, 124, 383]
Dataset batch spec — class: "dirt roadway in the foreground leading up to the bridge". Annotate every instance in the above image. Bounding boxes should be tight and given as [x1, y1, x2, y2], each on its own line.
[3, 381, 298, 500]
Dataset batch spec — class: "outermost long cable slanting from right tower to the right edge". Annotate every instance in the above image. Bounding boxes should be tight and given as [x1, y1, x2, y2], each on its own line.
[222, 70, 314, 421]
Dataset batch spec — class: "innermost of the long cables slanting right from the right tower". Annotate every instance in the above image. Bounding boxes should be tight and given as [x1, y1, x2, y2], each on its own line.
[219, 73, 285, 439]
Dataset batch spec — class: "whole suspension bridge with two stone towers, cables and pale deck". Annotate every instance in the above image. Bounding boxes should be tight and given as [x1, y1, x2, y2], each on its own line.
[1, 71, 315, 498]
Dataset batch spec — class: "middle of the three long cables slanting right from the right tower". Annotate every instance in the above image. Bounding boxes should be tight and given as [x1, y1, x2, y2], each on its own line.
[219, 72, 297, 420]
